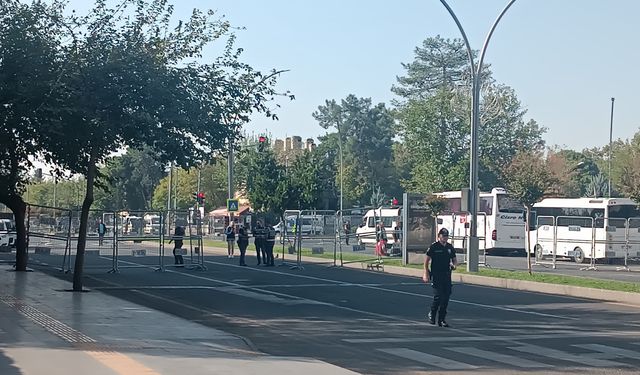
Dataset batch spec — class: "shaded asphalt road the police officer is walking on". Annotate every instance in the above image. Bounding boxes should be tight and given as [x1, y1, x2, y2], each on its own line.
[21, 250, 640, 374]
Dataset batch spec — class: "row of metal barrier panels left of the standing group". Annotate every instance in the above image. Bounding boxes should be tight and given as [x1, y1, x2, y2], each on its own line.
[26, 209, 206, 273]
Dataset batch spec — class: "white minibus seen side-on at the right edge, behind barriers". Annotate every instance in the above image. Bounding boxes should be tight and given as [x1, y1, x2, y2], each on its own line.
[531, 198, 640, 263]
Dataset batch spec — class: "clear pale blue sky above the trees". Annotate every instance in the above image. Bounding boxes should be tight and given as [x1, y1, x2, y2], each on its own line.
[61, 0, 640, 151]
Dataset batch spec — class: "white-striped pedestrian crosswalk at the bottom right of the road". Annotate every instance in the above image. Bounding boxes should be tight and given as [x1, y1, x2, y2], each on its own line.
[377, 342, 640, 370]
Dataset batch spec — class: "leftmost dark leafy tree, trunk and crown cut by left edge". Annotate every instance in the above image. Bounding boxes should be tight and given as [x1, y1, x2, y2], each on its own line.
[0, 0, 61, 271]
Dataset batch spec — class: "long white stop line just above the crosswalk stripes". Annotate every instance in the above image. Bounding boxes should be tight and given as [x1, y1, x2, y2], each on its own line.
[342, 331, 640, 345]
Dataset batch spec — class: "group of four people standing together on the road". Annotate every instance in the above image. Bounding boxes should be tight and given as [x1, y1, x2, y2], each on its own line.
[224, 221, 276, 267]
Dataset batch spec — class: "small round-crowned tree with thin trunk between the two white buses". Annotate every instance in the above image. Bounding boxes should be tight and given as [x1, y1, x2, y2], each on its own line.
[504, 150, 554, 274]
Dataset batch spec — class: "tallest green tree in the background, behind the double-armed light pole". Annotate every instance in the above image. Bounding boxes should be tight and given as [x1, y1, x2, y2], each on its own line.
[392, 37, 545, 193]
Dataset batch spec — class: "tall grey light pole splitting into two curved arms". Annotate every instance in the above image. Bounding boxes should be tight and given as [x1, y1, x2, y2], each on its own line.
[440, 0, 516, 272]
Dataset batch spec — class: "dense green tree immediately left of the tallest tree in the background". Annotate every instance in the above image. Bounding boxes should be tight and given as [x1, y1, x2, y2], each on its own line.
[313, 95, 395, 204]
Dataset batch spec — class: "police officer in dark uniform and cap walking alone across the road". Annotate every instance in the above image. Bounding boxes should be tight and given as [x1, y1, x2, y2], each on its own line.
[422, 228, 458, 327]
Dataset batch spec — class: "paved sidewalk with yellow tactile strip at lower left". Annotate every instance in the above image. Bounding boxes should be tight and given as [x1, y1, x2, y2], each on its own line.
[0, 264, 354, 375]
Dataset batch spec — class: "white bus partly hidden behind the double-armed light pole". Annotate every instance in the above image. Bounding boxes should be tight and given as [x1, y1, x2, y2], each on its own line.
[436, 188, 526, 254]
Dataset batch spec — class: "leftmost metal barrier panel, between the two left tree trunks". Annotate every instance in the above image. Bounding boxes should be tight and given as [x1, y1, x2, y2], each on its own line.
[26, 204, 73, 272]
